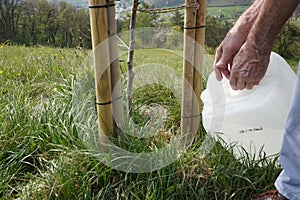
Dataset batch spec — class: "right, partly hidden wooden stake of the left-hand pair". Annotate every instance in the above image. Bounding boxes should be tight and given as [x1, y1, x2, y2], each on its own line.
[107, 0, 124, 130]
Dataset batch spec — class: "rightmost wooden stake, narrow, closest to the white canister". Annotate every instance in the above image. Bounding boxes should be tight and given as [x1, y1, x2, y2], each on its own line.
[192, 0, 206, 138]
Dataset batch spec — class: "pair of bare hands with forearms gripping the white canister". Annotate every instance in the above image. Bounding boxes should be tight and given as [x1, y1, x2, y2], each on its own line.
[214, 0, 300, 90]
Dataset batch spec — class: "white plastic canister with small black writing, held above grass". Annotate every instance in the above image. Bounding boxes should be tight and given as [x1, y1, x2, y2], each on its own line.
[201, 52, 296, 158]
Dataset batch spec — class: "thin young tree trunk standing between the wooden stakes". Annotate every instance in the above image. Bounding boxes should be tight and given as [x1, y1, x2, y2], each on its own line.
[127, 0, 139, 118]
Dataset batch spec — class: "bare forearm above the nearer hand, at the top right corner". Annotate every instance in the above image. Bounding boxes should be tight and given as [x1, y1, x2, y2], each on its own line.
[247, 0, 300, 53]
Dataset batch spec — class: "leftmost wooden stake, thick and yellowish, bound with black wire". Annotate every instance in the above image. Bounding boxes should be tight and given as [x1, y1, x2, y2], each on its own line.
[89, 0, 113, 143]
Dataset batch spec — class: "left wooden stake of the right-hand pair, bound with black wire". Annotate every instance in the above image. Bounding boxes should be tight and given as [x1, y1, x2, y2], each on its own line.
[181, 0, 197, 141]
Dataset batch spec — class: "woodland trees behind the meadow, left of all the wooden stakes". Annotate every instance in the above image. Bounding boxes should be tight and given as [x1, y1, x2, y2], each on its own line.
[0, 0, 91, 48]
